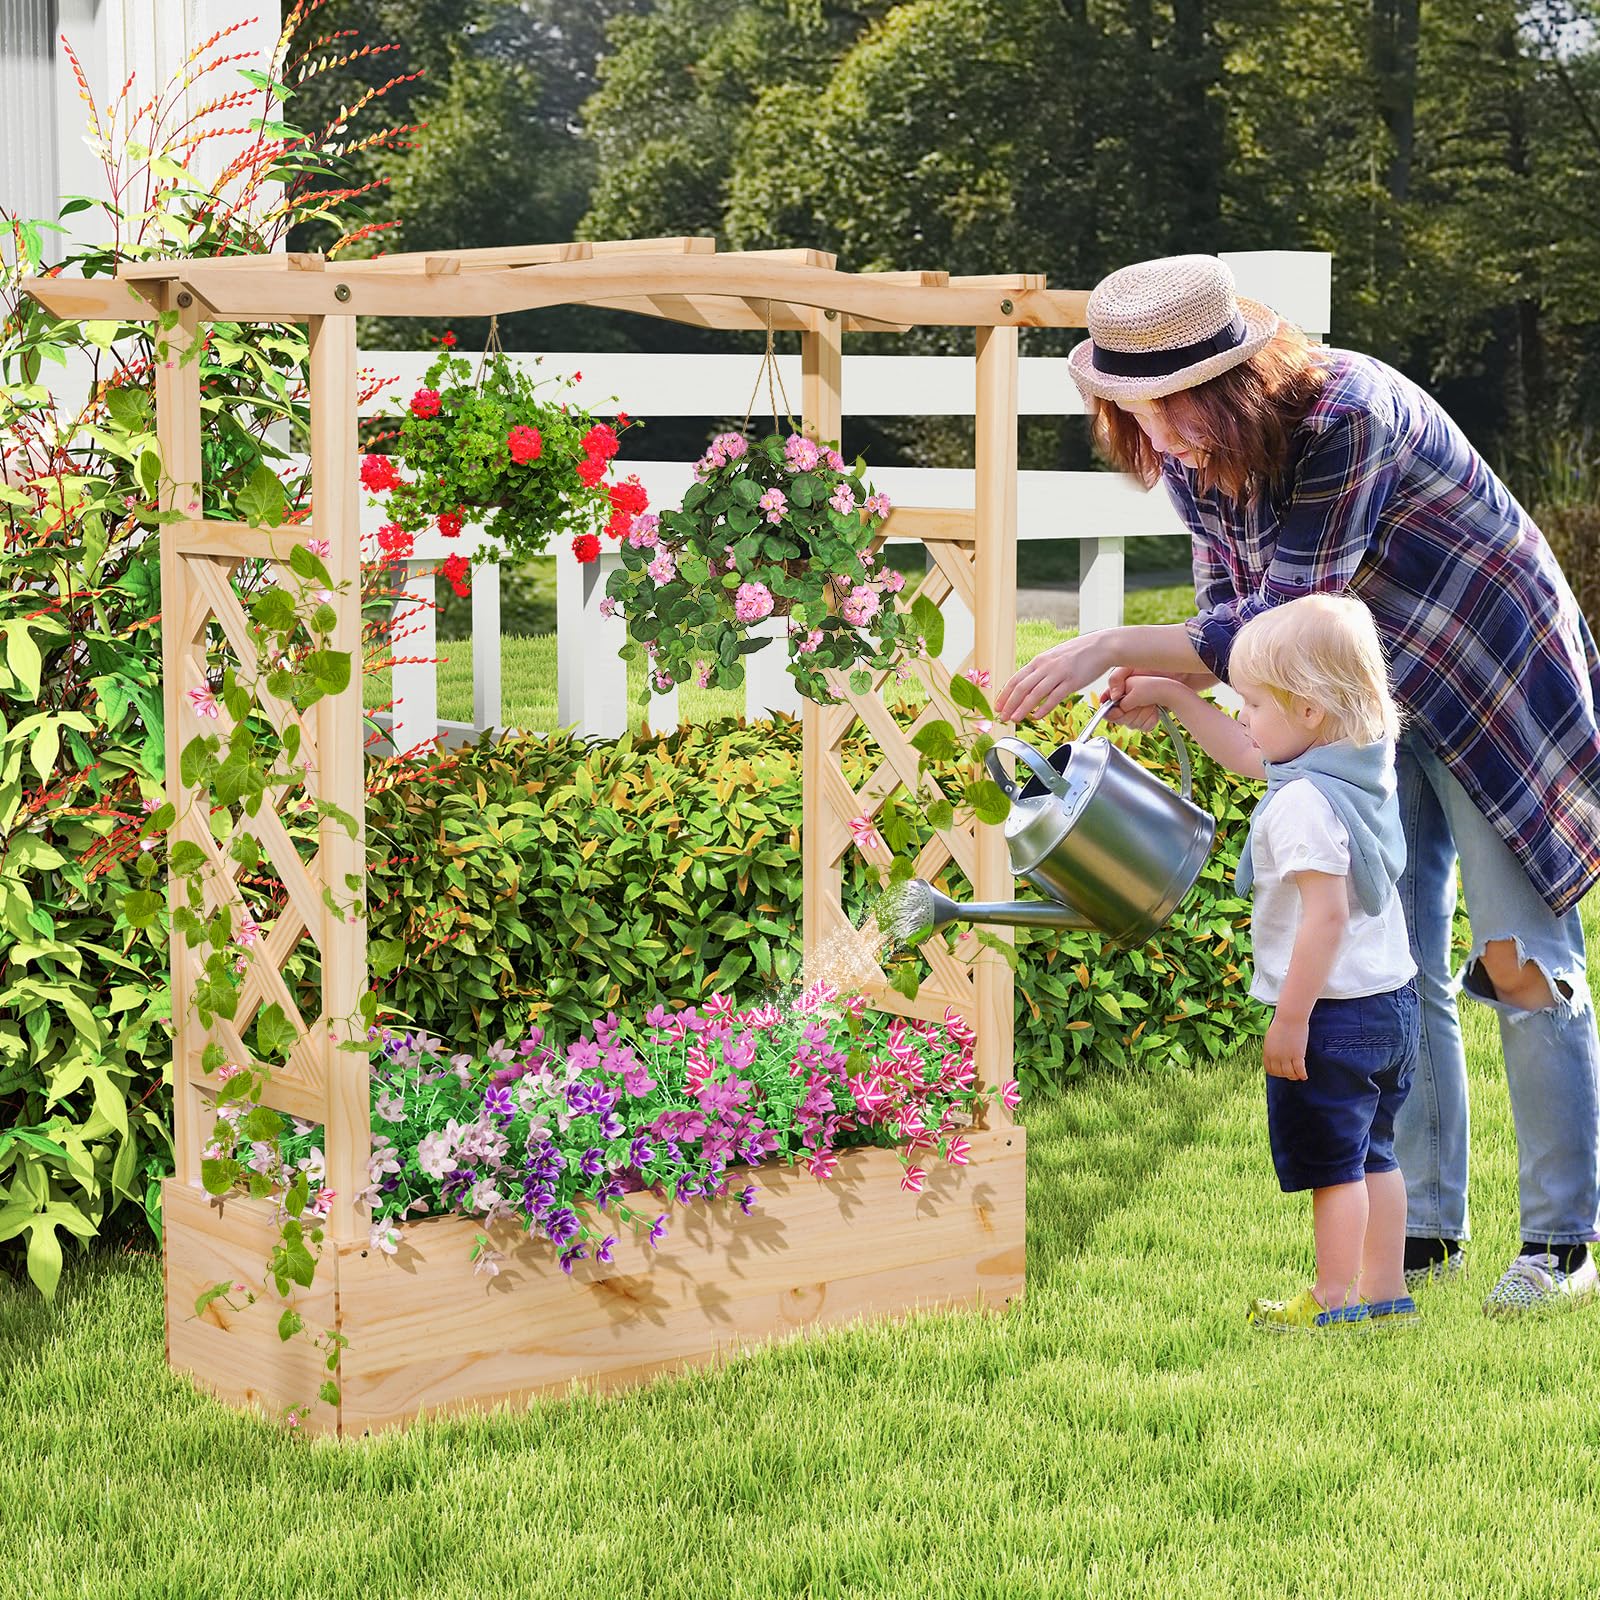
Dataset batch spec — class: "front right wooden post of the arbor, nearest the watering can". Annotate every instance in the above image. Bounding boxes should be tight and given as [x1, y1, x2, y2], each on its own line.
[971, 328, 1018, 1123]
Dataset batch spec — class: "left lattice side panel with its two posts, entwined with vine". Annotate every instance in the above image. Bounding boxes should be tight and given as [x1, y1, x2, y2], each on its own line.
[157, 297, 371, 1240]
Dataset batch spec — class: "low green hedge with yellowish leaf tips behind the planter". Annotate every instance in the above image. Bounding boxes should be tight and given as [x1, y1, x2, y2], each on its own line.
[368, 712, 1266, 1091]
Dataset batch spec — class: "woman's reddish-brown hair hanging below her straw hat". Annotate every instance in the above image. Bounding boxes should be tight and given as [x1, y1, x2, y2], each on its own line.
[1094, 322, 1328, 504]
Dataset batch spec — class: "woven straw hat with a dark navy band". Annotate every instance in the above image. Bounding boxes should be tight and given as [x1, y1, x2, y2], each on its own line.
[1067, 256, 1278, 400]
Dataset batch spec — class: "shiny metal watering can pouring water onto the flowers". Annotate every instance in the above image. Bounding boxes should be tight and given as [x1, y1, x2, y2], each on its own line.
[894, 701, 1216, 949]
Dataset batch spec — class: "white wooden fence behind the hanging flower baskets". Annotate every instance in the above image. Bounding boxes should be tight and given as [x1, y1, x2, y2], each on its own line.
[362, 251, 1331, 750]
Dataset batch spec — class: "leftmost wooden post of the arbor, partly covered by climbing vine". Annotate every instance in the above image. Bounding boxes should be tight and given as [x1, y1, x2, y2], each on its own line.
[155, 285, 210, 1184]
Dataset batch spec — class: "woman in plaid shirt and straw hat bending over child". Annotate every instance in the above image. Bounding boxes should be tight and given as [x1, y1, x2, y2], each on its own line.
[997, 256, 1600, 1314]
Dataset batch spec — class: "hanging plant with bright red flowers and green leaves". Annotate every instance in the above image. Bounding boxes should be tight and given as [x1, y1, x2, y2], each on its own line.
[362, 344, 648, 594]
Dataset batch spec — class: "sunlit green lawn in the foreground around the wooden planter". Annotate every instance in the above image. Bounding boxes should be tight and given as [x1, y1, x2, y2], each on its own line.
[0, 902, 1600, 1600]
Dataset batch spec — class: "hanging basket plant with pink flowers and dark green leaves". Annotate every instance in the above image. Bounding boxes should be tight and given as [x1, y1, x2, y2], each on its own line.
[605, 434, 915, 704]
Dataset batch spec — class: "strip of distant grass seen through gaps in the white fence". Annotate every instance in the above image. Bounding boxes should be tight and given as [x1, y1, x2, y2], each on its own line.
[365, 586, 1194, 731]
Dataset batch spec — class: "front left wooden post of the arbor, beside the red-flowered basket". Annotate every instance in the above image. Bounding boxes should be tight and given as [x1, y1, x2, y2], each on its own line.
[307, 317, 371, 1243]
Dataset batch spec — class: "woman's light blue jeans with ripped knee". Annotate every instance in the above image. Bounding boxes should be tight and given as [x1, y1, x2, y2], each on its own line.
[1395, 734, 1600, 1245]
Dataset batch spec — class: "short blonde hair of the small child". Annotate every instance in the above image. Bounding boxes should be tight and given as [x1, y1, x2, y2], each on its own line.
[1227, 595, 1400, 744]
